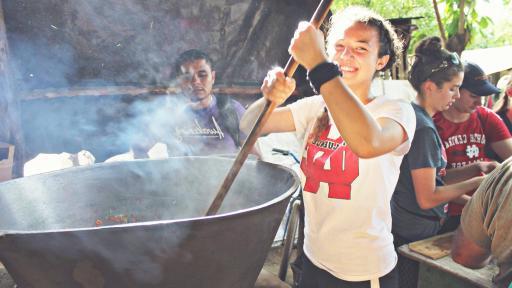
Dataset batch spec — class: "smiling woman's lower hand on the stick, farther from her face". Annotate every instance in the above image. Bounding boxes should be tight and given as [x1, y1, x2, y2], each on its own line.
[261, 67, 295, 106]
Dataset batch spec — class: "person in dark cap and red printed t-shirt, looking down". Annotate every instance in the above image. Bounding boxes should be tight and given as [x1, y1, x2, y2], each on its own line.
[433, 62, 512, 233]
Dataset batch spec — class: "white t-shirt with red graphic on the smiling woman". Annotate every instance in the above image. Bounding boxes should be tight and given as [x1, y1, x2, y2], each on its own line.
[288, 96, 416, 281]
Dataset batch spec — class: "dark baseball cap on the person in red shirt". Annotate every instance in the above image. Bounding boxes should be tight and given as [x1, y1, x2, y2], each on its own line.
[460, 62, 500, 96]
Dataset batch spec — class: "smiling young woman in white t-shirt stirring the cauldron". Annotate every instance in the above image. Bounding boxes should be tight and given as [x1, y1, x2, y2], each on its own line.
[241, 7, 415, 288]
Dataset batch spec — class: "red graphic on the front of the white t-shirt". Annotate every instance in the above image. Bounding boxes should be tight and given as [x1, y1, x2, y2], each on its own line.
[300, 125, 359, 200]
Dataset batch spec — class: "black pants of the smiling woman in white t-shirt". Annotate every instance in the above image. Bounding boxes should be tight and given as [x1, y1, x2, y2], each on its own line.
[299, 255, 398, 288]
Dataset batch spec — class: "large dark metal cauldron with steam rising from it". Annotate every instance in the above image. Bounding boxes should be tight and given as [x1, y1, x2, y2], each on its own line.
[0, 157, 299, 288]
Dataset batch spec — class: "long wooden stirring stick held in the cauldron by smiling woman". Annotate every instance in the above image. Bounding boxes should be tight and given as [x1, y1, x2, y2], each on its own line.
[206, 0, 333, 216]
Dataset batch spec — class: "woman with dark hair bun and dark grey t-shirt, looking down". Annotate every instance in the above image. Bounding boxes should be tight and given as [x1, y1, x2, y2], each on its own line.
[391, 37, 494, 288]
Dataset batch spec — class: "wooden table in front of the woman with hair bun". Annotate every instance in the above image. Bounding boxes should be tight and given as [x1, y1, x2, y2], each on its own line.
[398, 235, 498, 288]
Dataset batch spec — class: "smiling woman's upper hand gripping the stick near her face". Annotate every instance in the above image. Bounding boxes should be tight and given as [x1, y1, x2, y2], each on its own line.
[288, 21, 328, 70]
